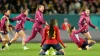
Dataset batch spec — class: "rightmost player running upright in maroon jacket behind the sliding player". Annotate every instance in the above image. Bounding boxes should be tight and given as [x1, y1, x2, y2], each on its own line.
[78, 9, 98, 39]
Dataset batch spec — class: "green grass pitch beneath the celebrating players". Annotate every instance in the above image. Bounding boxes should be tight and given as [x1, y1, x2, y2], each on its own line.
[0, 43, 100, 56]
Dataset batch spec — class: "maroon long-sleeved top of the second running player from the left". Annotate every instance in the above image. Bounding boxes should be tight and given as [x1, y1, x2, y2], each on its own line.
[12, 13, 34, 30]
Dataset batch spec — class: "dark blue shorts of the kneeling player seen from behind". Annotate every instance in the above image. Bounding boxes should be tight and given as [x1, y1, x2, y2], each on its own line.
[42, 44, 62, 51]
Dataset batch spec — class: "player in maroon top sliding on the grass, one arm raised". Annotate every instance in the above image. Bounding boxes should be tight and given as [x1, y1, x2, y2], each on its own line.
[69, 25, 96, 50]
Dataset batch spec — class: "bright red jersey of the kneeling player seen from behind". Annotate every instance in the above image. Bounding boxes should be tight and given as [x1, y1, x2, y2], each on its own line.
[41, 26, 64, 46]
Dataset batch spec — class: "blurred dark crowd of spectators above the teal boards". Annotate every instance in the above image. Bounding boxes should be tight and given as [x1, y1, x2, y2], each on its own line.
[0, 0, 100, 15]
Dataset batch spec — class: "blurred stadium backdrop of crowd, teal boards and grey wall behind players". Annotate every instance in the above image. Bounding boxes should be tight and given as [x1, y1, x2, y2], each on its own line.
[0, 0, 100, 42]
